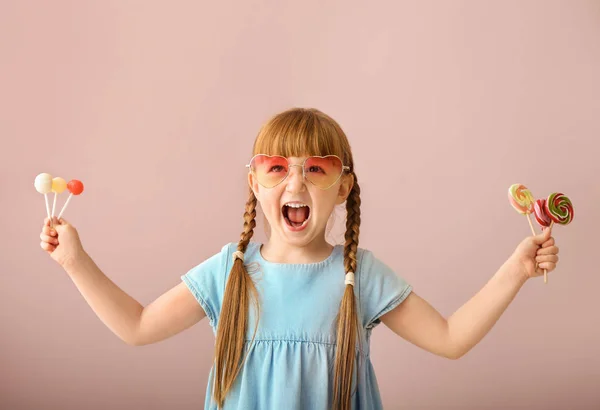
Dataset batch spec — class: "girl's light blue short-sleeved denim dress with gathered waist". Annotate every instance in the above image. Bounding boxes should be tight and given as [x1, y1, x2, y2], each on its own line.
[181, 242, 412, 410]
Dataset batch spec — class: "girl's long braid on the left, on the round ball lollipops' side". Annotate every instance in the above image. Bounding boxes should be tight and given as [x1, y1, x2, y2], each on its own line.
[213, 190, 259, 408]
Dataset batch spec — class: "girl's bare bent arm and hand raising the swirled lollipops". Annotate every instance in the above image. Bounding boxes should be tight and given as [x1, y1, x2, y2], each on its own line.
[381, 229, 558, 359]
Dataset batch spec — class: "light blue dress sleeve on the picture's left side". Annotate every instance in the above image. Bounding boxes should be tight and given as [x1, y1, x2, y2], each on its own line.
[181, 243, 231, 331]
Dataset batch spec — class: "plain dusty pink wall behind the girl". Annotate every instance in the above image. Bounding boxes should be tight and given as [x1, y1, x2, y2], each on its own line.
[0, 0, 600, 410]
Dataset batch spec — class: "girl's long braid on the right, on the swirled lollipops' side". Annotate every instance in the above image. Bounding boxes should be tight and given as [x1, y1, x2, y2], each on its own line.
[333, 174, 360, 410]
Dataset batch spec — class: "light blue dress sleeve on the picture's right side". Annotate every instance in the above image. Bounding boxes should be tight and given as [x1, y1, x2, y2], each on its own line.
[357, 248, 412, 329]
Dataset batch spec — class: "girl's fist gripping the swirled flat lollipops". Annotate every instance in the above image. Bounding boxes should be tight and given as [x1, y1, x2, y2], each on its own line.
[511, 228, 558, 279]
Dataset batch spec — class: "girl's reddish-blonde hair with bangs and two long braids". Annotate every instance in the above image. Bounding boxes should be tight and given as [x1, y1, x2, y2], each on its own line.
[213, 108, 362, 410]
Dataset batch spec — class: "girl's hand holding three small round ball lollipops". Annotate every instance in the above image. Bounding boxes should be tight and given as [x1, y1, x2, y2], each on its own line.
[40, 217, 84, 268]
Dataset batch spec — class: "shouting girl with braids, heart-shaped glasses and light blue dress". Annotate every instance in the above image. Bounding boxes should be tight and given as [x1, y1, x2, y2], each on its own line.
[41, 109, 558, 410]
